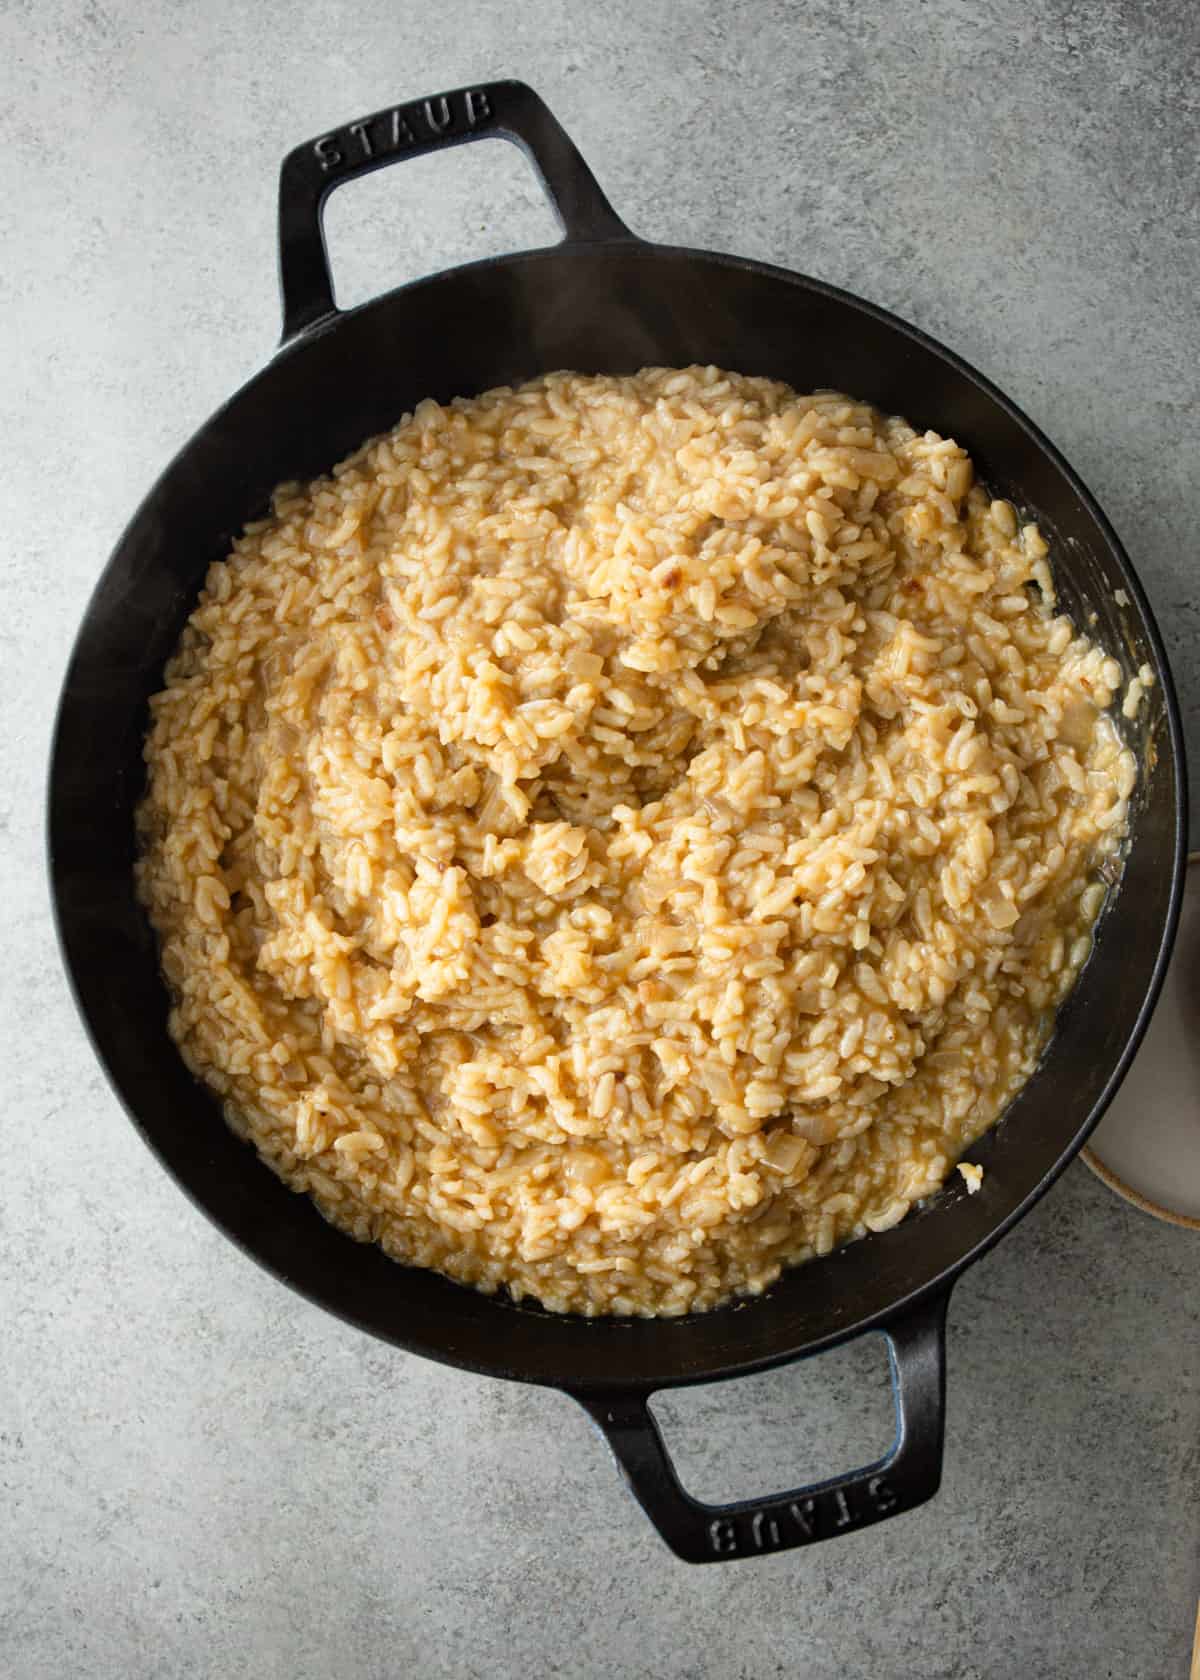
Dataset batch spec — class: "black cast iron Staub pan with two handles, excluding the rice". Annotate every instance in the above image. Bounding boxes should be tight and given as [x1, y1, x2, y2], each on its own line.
[49, 82, 1185, 1562]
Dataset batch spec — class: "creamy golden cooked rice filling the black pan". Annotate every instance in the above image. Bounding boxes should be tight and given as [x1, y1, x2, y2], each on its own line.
[138, 368, 1146, 1314]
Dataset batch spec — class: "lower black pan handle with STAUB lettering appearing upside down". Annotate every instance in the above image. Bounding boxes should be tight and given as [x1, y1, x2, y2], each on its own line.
[575, 1290, 950, 1564]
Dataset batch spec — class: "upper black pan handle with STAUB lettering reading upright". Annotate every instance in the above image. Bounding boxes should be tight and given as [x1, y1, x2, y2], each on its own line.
[279, 82, 634, 344]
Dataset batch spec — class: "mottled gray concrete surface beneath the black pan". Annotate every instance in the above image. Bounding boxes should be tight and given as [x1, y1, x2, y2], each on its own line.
[0, 0, 1200, 1680]
